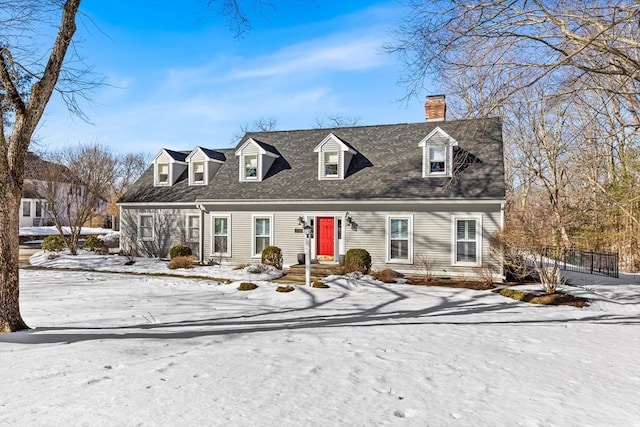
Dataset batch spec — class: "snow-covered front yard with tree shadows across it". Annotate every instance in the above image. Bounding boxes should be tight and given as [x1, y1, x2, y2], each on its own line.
[0, 255, 640, 427]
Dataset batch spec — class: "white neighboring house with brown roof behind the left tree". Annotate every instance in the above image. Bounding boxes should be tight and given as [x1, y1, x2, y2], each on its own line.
[20, 152, 110, 228]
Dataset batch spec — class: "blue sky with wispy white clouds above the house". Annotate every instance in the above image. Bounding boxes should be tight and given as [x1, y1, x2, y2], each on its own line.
[35, 0, 437, 154]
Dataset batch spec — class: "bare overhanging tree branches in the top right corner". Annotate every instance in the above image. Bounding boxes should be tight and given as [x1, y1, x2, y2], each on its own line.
[387, 0, 640, 106]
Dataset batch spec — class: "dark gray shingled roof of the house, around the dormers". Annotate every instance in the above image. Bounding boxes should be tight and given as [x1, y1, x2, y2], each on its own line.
[120, 118, 505, 203]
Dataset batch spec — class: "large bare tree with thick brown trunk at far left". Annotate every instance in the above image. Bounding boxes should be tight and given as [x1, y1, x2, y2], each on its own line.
[0, 0, 80, 332]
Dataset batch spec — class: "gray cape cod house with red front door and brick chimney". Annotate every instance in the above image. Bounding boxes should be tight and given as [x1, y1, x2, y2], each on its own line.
[120, 96, 505, 277]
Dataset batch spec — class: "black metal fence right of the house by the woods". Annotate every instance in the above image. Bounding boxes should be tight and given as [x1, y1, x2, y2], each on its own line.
[543, 248, 619, 278]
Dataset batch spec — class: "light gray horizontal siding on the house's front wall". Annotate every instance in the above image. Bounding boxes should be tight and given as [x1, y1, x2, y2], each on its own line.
[122, 203, 502, 277]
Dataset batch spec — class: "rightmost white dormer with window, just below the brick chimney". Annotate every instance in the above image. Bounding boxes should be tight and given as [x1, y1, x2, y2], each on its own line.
[418, 127, 458, 178]
